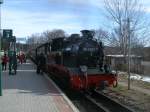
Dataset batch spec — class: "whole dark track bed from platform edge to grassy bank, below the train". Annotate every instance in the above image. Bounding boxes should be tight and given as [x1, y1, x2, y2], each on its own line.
[47, 72, 134, 112]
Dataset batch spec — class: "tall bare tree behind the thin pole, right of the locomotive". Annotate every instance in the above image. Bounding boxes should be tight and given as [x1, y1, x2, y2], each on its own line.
[104, 0, 149, 55]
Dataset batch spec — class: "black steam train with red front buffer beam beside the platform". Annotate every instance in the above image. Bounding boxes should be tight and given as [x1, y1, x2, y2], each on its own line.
[31, 30, 117, 91]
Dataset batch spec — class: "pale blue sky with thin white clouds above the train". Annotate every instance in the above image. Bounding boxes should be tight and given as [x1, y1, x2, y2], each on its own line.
[1, 0, 150, 37]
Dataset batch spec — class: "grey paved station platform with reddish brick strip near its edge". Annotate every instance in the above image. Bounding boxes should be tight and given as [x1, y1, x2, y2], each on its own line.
[0, 62, 78, 112]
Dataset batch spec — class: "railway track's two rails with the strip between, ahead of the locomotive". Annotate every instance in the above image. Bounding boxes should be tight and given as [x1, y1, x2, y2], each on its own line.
[85, 91, 134, 112]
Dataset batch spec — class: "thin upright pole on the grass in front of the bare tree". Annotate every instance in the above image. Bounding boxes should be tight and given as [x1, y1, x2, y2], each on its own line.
[127, 18, 131, 90]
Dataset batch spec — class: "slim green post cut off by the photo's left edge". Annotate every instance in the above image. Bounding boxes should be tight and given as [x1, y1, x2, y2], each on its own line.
[0, 0, 3, 96]
